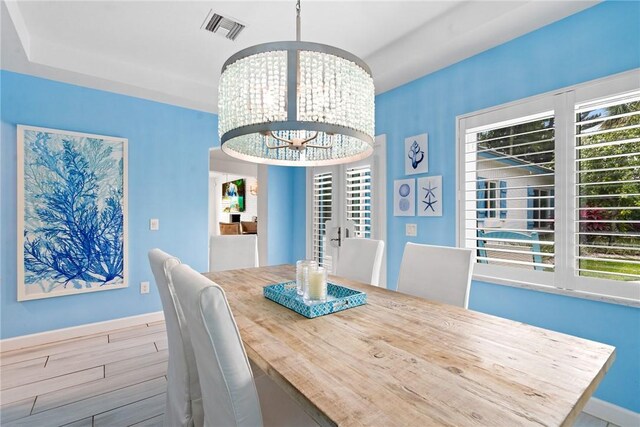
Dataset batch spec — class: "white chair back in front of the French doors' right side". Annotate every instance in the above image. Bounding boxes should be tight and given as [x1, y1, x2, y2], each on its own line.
[336, 238, 384, 286]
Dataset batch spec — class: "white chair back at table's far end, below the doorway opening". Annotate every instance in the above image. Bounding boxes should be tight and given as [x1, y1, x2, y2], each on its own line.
[209, 234, 258, 271]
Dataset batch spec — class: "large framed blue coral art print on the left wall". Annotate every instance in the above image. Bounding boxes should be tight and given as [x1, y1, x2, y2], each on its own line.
[17, 125, 128, 301]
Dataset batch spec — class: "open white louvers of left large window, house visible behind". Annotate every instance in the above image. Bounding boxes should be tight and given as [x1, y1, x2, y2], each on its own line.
[464, 112, 555, 271]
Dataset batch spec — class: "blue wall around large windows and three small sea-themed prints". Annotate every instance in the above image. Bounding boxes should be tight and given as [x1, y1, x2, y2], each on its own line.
[376, 2, 640, 412]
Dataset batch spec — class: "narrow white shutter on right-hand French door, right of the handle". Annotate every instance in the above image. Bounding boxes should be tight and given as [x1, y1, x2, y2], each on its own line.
[345, 165, 371, 238]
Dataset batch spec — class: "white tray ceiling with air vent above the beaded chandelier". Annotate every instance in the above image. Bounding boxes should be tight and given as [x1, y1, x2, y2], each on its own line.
[1, 0, 597, 112]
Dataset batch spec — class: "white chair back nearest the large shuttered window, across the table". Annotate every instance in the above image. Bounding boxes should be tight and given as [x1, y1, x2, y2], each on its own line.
[398, 243, 473, 308]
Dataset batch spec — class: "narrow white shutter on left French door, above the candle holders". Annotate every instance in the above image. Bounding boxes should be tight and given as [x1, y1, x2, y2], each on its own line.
[312, 172, 333, 265]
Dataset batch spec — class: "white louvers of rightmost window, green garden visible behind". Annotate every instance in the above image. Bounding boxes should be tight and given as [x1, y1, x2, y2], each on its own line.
[573, 92, 640, 281]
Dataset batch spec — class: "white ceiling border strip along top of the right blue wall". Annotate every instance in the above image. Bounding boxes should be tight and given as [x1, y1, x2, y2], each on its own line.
[365, 0, 600, 93]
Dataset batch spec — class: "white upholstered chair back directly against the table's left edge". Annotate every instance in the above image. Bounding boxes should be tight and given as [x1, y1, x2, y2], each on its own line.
[171, 264, 262, 427]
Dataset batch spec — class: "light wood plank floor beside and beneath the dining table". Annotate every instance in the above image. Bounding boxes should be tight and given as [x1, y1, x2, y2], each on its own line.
[0, 322, 613, 427]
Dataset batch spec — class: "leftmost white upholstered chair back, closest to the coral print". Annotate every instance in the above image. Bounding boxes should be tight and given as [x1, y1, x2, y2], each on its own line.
[149, 249, 204, 427]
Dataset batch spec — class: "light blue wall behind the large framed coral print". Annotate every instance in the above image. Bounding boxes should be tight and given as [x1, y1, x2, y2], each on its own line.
[0, 71, 218, 338]
